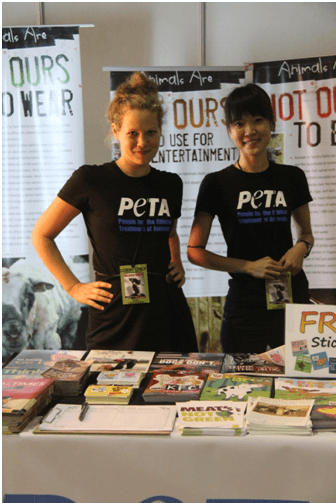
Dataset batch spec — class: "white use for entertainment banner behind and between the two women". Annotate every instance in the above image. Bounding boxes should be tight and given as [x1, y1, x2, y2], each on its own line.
[105, 67, 245, 297]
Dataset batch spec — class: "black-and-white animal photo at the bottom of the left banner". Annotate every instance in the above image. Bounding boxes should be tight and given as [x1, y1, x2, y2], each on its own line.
[2, 257, 89, 361]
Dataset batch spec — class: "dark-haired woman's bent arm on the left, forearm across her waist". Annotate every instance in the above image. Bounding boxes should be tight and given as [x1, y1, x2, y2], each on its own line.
[188, 211, 283, 279]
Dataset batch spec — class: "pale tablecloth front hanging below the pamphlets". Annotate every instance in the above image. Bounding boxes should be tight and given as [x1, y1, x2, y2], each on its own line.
[3, 422, 336, 503]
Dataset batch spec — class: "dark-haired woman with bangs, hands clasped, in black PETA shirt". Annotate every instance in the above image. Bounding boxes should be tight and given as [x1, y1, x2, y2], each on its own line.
[188, 84, 314, 353]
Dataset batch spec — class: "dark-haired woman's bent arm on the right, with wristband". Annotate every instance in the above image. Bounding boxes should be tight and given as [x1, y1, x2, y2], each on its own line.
[280, 204, 314, 276]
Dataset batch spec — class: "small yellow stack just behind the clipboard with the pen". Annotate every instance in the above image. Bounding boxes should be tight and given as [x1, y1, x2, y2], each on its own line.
[84, 384, 134, 405]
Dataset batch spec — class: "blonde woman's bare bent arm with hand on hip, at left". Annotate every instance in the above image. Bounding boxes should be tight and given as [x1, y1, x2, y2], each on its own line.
[32, 197, 113, 310]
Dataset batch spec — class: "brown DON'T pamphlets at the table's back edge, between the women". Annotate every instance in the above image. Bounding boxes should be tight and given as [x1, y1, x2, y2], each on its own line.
[149, 352, 224, 374]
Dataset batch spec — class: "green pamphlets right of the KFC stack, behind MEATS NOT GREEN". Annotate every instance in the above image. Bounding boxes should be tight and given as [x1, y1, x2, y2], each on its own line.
[200, 373, 273, 402]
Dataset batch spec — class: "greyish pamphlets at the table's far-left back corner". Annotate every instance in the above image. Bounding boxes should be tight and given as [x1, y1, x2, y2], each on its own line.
[2, 349, 86, 379]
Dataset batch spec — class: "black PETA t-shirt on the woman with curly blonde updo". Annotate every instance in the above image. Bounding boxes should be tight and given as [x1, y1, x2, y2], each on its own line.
[58, 162, 182, 274]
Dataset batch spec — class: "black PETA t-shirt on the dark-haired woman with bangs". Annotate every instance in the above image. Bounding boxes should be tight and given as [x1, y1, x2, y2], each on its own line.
[195, 162, 312, 266]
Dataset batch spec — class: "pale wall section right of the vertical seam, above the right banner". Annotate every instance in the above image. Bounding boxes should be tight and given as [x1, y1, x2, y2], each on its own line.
[206, 2, 336, 66]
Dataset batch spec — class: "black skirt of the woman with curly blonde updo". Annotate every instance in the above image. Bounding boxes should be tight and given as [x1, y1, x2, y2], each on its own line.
[86, 273, 198, 353]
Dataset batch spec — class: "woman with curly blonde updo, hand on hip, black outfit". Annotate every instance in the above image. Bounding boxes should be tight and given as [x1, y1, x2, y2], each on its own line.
[32, 72, 197, 352]
